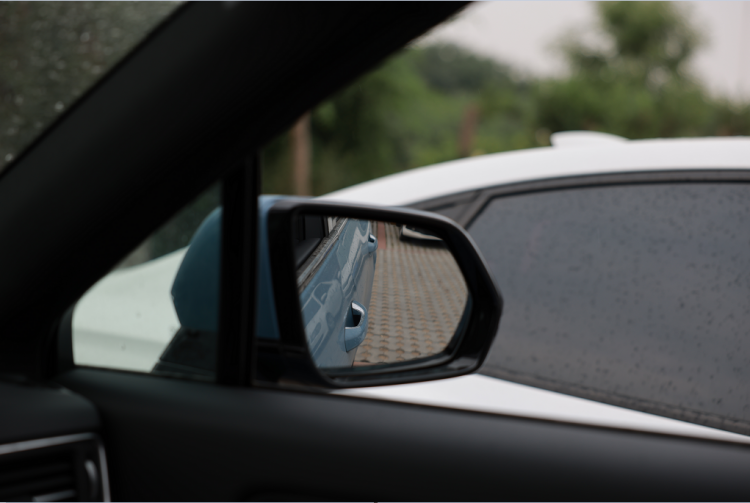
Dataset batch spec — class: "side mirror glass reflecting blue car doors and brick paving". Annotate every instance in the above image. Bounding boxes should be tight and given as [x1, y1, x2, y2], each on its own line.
[293, 215, 467, 370]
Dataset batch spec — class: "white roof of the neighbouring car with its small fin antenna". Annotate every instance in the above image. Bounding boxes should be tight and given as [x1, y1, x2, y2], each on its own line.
[321, 137, 750, 206]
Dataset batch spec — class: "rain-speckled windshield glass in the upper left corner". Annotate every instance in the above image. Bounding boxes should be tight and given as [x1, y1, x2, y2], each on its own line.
[0, 2, 180, 171]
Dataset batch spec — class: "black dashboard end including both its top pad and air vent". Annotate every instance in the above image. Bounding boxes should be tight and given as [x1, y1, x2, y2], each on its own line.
[0, 379, 110, 501]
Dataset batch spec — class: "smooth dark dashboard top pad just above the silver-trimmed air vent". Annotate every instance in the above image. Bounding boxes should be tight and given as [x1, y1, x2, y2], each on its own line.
[0, 381, 99, 444]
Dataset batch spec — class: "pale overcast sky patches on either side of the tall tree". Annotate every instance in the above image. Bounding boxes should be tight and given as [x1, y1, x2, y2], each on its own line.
[426, 1, 750, 100]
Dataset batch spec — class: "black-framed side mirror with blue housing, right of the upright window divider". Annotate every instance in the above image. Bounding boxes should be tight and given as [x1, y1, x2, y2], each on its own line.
[256, 198, 502, 388]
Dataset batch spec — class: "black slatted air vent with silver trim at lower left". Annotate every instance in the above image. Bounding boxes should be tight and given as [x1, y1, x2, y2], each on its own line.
[0, 434, 109, 501]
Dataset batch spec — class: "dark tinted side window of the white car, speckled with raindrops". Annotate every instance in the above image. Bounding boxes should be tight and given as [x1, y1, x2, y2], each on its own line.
[469, 183, 750, 433]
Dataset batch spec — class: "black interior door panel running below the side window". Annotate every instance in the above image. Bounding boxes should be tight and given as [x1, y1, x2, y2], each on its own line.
[57, 368, 750, 501]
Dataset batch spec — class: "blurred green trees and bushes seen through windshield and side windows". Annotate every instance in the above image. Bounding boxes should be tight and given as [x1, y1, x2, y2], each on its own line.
[0, 2, 750, 263]
